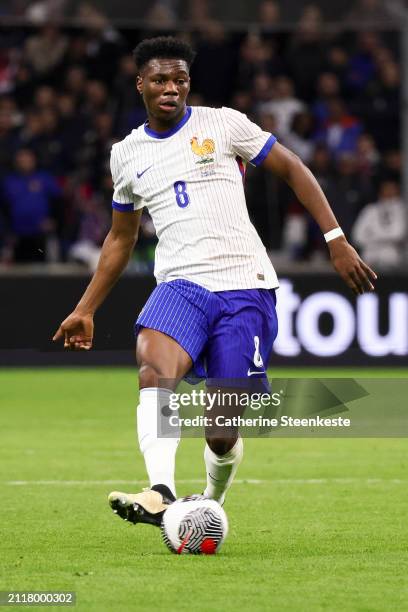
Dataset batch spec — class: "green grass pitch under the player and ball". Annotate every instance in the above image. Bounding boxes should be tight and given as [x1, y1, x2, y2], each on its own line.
[0, 368, 408, 612]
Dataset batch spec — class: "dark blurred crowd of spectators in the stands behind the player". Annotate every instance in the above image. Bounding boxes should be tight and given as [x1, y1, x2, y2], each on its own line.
[0, 0, 406, 271]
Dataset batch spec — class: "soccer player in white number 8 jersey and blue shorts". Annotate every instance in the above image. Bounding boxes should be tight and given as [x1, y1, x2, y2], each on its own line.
[54, 37, 376, 525]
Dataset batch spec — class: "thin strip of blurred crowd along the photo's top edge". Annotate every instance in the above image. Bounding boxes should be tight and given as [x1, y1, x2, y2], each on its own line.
[0, 0, 406, 29]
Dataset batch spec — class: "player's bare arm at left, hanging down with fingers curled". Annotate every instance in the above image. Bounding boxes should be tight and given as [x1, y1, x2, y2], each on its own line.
[53, 210, 142, 350]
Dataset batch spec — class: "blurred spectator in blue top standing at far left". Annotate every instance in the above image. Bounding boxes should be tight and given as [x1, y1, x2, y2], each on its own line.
[3, 149, 61, 262]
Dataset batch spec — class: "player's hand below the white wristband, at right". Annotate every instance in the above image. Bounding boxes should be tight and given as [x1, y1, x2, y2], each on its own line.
[328, 236, 377, 295]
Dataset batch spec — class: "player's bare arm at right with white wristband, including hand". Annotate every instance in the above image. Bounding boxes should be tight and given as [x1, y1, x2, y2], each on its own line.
[262, 142, 377, 295]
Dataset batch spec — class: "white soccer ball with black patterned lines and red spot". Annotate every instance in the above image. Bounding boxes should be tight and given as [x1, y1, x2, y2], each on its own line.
[161, 495, 228, 555]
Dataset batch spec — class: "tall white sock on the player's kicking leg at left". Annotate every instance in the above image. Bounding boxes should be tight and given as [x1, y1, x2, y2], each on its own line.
[137, 387, 180, 497]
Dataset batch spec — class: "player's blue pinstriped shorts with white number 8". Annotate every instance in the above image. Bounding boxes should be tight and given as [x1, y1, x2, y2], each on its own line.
[135, 279, 278, 384]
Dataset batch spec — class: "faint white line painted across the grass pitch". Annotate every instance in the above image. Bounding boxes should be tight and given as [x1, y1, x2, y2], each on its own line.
[1, 478, 408, 487]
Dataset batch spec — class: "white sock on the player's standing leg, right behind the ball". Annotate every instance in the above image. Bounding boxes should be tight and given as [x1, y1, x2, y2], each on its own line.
[204, 437, 244, 504]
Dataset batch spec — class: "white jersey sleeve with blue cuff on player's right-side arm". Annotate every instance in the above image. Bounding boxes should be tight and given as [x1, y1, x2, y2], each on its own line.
[222, 107, 276, 166]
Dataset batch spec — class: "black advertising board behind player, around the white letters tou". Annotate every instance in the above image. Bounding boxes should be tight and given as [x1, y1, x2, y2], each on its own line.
[0, 273, 408, 367]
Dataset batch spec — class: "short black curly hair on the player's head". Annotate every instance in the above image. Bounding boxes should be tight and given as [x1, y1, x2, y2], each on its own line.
[133, 36, 196, 70]
